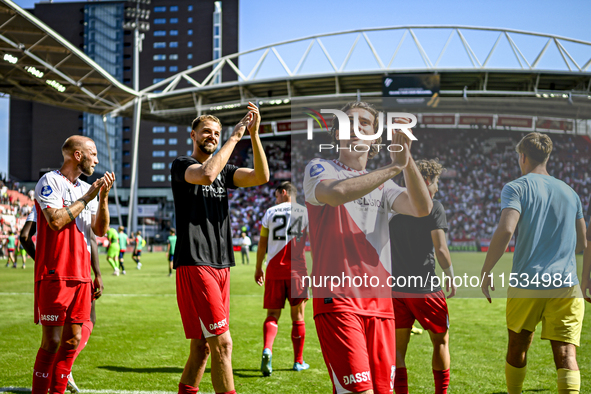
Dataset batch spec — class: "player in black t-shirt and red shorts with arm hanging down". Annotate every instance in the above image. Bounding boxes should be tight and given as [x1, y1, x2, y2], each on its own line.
[390, 160, 456, 394]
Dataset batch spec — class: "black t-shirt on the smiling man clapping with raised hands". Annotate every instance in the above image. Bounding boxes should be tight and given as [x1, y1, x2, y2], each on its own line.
[170, 156, 238, 268]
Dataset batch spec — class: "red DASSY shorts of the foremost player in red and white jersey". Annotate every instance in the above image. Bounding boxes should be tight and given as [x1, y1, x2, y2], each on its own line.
[314, 313, 396, 394]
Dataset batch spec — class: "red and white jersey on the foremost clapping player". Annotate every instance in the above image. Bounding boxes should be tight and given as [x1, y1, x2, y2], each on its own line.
[304, 159, 405, 318]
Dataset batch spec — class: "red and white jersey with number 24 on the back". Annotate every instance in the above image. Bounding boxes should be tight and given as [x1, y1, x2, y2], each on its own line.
[262, 202, 308, 279]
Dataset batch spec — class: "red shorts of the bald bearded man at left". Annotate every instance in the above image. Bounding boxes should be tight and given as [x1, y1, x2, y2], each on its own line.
[35, 280, 92, 326]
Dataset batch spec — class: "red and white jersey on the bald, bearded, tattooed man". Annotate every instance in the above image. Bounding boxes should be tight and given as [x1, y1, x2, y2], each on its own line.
[35, 171, 98, 282]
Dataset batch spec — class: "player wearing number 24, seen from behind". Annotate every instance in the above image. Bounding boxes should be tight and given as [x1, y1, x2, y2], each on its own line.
[254, 182, 310, 376]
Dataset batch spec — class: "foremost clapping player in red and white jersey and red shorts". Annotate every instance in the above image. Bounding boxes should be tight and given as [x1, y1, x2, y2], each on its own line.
[304, 102, 433, 394]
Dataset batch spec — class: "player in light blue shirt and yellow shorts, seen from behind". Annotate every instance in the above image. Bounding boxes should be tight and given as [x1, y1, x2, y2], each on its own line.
[481, 133, 586, 394]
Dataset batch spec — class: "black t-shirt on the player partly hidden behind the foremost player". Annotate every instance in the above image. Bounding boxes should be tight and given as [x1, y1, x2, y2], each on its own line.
[390, 200, 447, 294]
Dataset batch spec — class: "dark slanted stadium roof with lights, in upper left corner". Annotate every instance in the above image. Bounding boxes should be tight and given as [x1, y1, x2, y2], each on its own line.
[0, 0, 137, 114]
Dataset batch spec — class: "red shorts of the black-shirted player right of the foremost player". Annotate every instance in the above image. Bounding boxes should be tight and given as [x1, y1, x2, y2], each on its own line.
[392, 291, 449, 334]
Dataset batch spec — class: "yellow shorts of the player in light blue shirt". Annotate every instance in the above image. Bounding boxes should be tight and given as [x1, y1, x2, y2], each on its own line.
[507, 285, 585, 346]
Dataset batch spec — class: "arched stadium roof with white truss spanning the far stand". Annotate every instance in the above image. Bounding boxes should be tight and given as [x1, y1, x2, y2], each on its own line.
[114, 26, 591, 125]
